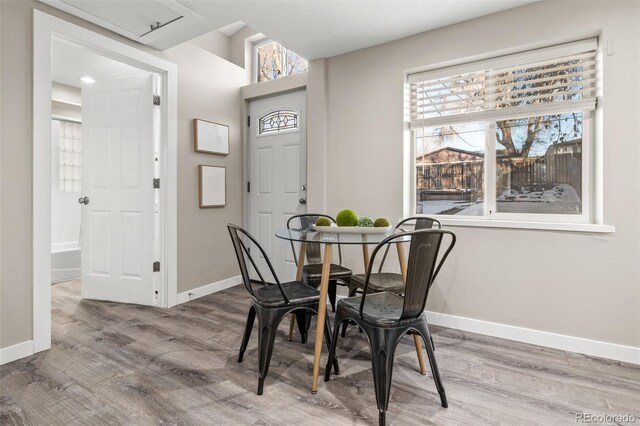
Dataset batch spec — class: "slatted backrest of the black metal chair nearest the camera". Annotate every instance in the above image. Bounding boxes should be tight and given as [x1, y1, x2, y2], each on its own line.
[360, 229, 456, 320]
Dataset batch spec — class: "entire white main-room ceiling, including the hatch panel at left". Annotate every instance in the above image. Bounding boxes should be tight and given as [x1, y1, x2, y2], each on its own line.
[40, 0, 536, 59]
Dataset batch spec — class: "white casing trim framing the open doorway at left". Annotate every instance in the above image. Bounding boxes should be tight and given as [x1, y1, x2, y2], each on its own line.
[32, 10, 178, 353]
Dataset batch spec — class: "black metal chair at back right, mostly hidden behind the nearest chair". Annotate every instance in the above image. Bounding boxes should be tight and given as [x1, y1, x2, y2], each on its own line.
[342, 216, 442, 337]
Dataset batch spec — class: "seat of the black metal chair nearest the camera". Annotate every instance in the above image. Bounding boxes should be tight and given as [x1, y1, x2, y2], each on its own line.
[338, 291, 404, 326]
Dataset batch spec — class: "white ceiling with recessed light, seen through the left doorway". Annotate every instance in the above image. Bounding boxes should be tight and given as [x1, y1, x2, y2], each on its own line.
[51, 39, 146, 87]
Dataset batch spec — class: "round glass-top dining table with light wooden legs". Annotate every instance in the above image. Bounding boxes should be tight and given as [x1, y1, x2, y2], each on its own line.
[276, 228, 426, 393]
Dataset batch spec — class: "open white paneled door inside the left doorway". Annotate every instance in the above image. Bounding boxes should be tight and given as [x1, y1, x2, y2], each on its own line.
[81, 75, 159, 305]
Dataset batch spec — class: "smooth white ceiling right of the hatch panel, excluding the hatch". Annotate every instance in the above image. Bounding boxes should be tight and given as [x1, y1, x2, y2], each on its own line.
[174, 0, 535, 59]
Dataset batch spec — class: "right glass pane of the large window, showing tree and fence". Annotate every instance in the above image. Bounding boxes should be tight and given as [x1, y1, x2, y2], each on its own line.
[496, 112, 583, 214]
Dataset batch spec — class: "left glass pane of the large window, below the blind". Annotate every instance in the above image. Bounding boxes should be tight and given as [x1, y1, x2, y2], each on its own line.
[414, 123, 485, 216]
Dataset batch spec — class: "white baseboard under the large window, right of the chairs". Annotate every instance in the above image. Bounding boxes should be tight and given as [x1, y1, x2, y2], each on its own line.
[427, 311, 640, 365]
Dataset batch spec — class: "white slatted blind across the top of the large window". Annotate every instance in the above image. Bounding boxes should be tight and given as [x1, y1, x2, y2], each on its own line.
[408, 38, 598, 129]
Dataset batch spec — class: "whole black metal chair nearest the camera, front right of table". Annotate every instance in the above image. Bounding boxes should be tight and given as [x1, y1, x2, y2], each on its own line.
[324, 229, 456, 425]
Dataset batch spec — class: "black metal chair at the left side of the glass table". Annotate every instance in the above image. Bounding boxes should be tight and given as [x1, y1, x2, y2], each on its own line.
[227, 224, 340, 395]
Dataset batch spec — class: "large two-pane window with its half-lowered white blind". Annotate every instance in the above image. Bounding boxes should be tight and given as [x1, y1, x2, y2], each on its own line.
[407, 39, 600, 222]
